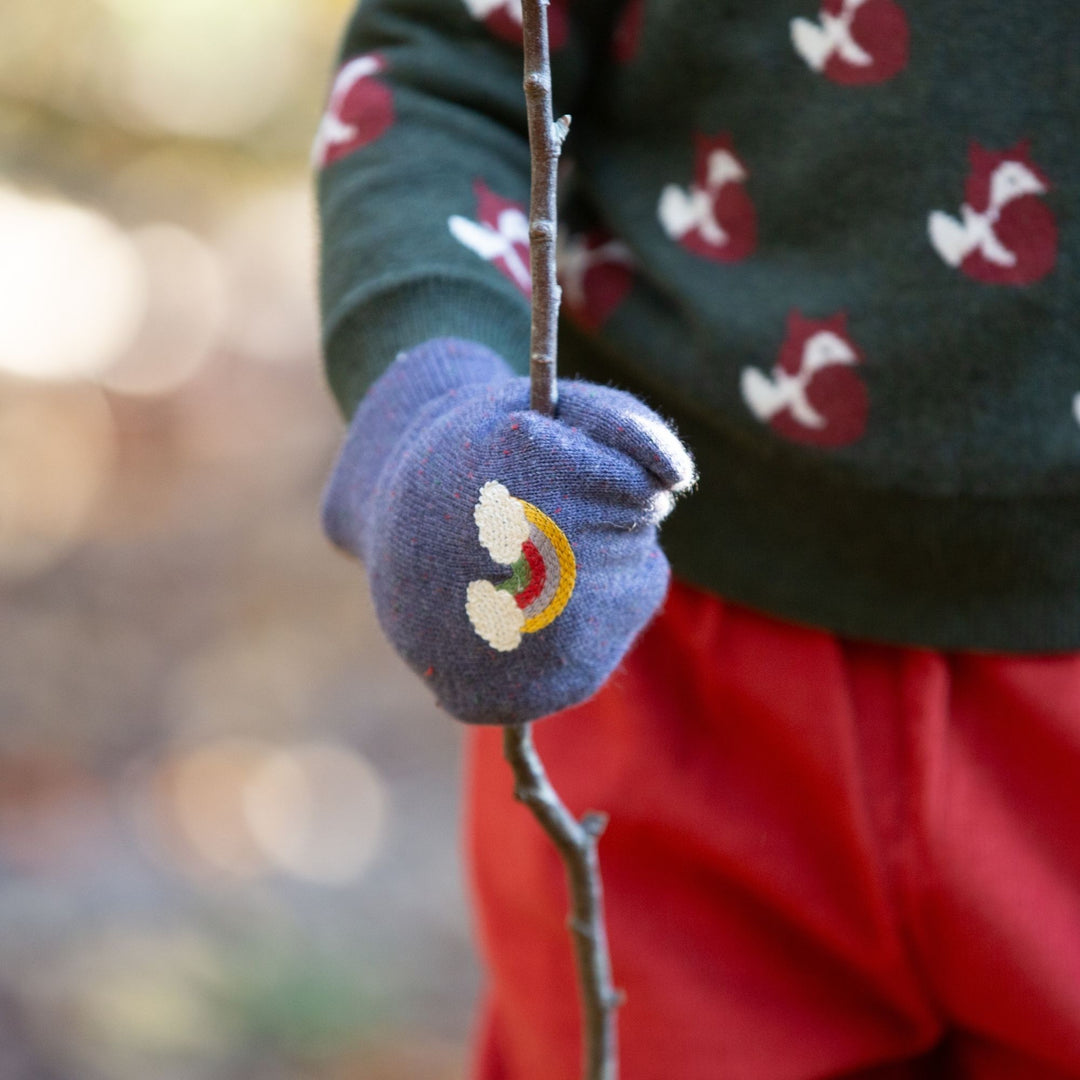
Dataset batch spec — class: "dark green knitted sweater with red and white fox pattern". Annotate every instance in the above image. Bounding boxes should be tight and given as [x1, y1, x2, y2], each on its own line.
[314, 0, 1080, 651]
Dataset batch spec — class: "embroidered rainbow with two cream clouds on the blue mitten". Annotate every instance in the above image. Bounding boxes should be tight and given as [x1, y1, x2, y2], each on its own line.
[465, 480, 577, 652]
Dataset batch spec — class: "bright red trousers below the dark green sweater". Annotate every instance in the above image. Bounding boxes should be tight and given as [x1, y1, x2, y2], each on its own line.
[467, 585, 1080, 1080]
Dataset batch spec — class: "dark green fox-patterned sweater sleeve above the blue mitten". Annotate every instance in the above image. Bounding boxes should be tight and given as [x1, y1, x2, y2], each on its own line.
[313, 0, 610, 416]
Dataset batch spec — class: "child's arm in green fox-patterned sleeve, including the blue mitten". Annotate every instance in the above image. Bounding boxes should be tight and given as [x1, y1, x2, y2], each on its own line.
[315, 0, 693, 723]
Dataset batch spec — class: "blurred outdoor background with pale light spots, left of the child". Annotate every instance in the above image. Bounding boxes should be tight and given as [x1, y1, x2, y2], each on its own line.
[0, 0, 481, 1080]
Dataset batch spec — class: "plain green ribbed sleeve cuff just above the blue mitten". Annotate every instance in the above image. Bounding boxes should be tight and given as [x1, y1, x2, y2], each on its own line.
[324, 276, 529, 419]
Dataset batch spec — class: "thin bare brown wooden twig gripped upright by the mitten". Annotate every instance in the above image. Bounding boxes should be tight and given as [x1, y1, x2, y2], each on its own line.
[503, 0, 621, 1080]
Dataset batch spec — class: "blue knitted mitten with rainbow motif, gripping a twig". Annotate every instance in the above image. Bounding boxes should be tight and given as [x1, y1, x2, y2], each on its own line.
[323, 338, 694, 724]
